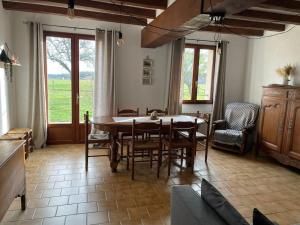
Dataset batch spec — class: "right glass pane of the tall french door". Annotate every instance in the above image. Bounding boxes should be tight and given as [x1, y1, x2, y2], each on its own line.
[79, 40, 96, 122]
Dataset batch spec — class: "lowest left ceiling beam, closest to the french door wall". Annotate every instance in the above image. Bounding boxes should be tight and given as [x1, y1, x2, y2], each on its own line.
[2, 1, 147, 26]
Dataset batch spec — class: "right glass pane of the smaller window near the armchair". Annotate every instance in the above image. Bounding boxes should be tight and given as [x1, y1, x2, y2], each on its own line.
[197, 49, 214, 100]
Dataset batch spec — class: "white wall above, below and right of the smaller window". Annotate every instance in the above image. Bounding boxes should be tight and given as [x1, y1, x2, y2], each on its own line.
[183, 32, 248, 112]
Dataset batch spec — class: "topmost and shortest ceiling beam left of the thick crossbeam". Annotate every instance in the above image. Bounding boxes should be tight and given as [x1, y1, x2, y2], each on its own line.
[101, 0, 168, 9]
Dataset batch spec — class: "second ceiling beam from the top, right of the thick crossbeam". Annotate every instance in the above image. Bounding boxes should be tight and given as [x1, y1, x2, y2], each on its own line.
[233, 9, 300, 25]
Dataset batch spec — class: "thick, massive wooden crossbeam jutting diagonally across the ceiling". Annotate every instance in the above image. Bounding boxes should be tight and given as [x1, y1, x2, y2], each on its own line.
[142, 0, 266, 48]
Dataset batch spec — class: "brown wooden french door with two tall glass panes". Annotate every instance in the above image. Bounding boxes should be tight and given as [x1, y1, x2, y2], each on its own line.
[44, 32, 96, 144]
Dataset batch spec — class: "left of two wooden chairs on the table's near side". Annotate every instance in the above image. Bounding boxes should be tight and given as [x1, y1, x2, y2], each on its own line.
[127, 120, 162, 180]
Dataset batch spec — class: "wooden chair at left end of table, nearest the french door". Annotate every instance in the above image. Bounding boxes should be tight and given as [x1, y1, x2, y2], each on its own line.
[84, 111, 111, 171]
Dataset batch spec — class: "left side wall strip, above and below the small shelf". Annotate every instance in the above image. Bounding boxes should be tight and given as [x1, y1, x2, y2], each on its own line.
[0, 1, 15, 135]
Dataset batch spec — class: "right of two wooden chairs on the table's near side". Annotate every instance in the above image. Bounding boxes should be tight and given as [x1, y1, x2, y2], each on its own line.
[165, 119, 197, 176]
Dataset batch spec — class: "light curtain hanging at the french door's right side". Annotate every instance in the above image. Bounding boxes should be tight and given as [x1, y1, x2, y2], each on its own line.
[93, 29, 116, 117]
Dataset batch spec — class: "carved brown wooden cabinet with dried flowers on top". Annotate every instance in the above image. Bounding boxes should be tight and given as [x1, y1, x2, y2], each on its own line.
[258, 86, 300, 169]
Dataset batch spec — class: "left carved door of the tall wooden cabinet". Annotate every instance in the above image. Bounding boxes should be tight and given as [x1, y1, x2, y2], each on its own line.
[260, 97, 287, 152]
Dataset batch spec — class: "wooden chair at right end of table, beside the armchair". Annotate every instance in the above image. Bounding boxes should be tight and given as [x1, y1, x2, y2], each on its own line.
[180, 111, 211, 162]
